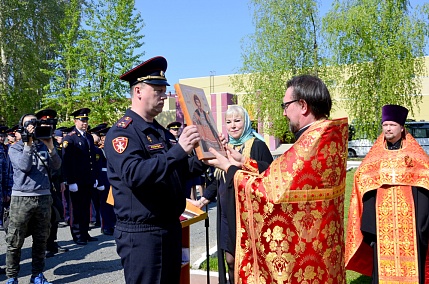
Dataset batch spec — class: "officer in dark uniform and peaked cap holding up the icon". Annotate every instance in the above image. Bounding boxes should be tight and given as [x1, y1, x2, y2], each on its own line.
[104, 57, 207, 284]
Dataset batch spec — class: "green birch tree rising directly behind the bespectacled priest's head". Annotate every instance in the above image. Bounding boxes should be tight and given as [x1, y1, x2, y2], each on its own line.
[233, 0, 324, 140]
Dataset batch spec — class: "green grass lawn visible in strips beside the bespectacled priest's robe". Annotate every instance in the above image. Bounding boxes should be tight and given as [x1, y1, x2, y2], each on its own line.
[200, 170, 371, 284]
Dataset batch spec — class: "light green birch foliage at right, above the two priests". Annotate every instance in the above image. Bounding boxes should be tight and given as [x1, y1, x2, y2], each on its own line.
[233, 0, 429, 142]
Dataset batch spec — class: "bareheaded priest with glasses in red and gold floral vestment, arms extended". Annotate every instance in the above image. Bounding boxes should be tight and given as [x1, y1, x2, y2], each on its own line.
[208, 75, 348, 284]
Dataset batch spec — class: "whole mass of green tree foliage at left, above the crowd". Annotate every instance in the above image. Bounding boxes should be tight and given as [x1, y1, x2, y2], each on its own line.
[0, 0, 144, 126]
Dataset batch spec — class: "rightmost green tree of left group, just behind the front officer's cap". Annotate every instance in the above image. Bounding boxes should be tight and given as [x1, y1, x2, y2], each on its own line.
[77, 0, 144, 123]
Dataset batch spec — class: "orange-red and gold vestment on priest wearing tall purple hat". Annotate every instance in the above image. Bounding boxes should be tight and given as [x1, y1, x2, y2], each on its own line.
[345, 133, 429, 283]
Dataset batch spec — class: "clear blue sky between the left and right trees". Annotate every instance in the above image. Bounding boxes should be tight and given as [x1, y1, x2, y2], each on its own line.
[136, 0, 427, 93]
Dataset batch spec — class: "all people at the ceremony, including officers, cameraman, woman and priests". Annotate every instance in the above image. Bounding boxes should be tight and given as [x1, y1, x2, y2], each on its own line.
[0, 53, 429, 284]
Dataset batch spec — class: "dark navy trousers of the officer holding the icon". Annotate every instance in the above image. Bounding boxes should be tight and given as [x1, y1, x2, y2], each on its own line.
[114, 222, 182, 284]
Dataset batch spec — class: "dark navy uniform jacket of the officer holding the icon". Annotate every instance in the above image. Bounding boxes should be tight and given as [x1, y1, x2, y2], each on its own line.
[104, 109, 207, 231]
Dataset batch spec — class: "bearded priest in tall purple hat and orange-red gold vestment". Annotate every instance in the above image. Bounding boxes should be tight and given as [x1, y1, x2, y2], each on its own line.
[345, 105, 429, 283]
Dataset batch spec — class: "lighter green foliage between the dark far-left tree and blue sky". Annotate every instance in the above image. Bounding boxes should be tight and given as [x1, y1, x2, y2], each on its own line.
[44, 0, 143, 125]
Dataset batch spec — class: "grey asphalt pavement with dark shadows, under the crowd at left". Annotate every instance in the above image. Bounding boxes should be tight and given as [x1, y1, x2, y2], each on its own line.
[0, 201, 218, 284]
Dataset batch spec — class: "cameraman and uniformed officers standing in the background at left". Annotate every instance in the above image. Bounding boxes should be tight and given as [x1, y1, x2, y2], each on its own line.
[0, 108, 116, 284]
